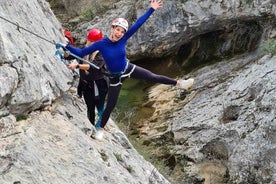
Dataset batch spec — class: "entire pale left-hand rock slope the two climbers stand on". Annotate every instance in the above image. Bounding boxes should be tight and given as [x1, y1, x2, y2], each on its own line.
[0, 0, 169, 184]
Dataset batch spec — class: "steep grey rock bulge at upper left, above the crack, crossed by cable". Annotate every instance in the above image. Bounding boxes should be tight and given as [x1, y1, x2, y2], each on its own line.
[0, 0, 73, 115]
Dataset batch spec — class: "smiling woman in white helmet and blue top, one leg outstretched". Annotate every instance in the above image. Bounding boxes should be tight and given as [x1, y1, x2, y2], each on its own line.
[64, 0, 194, 139]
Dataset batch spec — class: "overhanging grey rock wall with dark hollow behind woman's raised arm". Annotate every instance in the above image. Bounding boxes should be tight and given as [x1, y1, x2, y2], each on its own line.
[59, 0, 275, 62]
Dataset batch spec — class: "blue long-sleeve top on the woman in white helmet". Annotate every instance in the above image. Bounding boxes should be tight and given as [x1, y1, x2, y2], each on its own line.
[66, 8, 154, 74]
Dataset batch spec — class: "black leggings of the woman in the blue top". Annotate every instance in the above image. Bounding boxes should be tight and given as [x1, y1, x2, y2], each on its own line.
[101, 63, 177, 128]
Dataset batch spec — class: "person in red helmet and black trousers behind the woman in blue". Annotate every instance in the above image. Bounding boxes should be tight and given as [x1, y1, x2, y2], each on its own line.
[68, 28, 108, 129]
